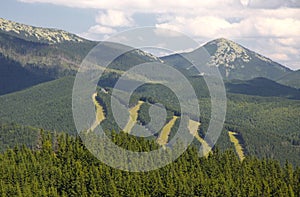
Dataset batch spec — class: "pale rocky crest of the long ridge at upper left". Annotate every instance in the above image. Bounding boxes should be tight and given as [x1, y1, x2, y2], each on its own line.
[0, 18, 84, 44]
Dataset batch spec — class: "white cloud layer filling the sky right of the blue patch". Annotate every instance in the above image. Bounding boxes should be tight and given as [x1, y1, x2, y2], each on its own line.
[20, 0, 300, 69]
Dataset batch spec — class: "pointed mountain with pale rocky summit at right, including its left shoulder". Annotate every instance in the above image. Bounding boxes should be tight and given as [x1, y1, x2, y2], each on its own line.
[161, 38, 292, 80]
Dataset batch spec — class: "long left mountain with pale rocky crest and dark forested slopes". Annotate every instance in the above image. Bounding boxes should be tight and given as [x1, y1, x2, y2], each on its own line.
[0, 19, 160, 95]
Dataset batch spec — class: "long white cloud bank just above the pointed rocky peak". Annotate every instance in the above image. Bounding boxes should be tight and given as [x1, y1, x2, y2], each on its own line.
[156, 16, 300, 39]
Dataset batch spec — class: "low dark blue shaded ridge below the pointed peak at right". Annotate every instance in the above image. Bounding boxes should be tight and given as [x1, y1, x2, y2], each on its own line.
[226, 77, 300, 99]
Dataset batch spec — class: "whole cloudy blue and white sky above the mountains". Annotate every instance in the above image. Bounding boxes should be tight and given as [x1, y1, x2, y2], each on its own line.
[0, 0, 300, 70]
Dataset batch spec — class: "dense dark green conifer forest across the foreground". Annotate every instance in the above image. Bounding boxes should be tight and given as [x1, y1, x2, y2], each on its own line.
[0, 132, 300, 197]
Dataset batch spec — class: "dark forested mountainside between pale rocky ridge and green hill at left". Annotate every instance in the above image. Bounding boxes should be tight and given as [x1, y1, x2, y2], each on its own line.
[0, 32, 93, 95]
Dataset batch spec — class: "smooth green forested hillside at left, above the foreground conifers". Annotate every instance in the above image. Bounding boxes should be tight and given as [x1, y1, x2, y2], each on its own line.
[0, 77, 76, 133]
